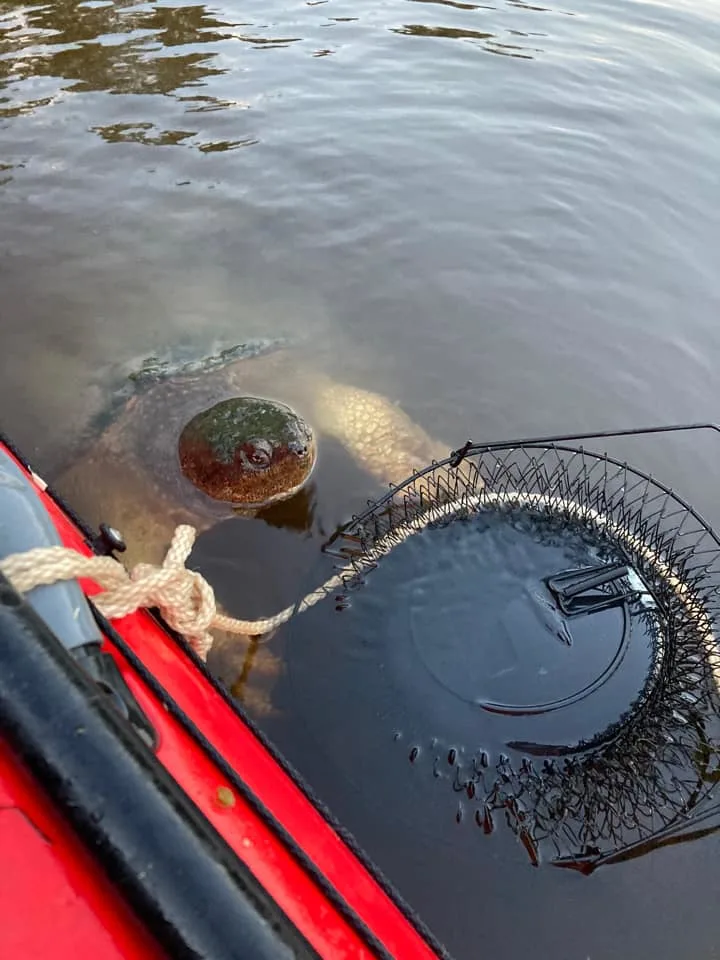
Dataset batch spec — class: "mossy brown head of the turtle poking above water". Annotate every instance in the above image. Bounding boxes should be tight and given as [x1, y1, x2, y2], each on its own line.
[178, 397, 316, 509]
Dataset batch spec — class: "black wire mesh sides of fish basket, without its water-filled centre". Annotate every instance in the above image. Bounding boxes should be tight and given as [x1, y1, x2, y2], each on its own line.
[314, 442, 720, 871]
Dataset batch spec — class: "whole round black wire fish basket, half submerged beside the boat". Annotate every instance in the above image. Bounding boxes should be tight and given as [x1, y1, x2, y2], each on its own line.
[291, 441, 720, 872]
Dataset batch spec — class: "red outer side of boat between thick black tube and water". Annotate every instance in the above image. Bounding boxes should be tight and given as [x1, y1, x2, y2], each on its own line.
[0, 446, 442, 960]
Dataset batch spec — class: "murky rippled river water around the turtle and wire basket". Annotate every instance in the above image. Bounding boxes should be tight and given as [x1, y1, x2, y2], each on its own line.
[0, 0, 720, 960]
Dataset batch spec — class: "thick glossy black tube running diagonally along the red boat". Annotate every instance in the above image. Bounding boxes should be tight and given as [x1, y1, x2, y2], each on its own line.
[0, 575, 319, 960]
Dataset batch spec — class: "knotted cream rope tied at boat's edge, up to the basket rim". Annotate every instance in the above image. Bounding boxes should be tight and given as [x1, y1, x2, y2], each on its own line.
[0, 525, 341, 659]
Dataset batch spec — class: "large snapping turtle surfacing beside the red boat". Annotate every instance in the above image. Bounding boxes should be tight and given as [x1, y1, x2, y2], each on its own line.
[55, 345, 449, 712]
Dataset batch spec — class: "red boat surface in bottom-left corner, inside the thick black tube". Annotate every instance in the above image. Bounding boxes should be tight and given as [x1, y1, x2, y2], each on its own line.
[0, 741, 164, 960]
